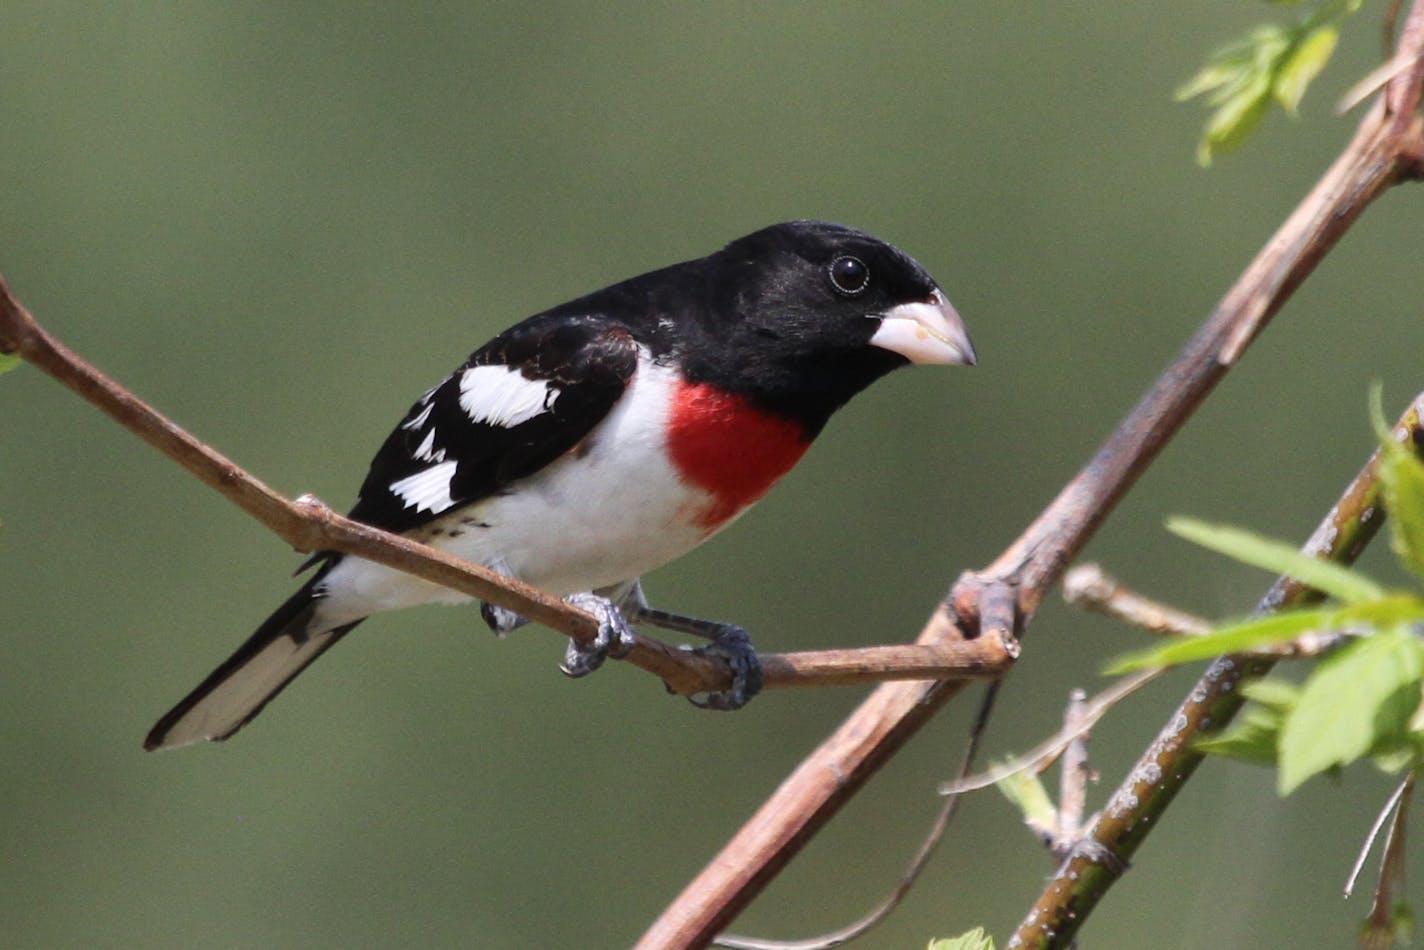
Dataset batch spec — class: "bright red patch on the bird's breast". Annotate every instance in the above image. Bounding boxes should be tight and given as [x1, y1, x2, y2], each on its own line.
[668, 383, 810, 531]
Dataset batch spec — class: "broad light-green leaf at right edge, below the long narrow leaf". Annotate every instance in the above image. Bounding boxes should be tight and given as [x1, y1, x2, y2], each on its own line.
[1277, 625, 1424, 796]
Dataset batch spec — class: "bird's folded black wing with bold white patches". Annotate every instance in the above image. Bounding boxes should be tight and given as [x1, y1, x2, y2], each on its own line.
[350, 313, 638, 533]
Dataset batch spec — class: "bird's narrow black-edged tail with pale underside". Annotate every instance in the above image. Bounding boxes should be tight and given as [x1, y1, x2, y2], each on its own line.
[144, 581, 360, 749]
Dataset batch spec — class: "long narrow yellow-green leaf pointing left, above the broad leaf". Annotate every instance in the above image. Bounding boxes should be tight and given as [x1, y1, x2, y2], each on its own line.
[1104, 594, 1424, 677]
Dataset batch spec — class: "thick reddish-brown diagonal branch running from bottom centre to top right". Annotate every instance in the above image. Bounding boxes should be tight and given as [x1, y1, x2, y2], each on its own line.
[638, 0, 1424, 950]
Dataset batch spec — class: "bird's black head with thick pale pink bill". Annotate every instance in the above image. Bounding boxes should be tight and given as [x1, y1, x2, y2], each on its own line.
[684, 221, 975, 432]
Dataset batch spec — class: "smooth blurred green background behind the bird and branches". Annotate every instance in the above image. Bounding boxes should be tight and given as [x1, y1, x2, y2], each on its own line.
[0, 0, 1424, 949]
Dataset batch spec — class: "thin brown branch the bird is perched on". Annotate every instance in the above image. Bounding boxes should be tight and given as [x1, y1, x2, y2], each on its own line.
[0, 276, 1018, 695]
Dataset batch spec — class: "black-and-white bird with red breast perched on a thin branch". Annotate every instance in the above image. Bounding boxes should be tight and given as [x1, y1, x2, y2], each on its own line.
[144, 221, 977, 749]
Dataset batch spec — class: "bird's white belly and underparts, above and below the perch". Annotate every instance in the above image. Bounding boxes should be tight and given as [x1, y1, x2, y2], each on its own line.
[307, 362, 722, 625]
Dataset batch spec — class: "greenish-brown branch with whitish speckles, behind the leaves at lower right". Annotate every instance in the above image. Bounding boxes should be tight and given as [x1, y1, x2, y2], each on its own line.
[1008, 393, 1424, 950]
